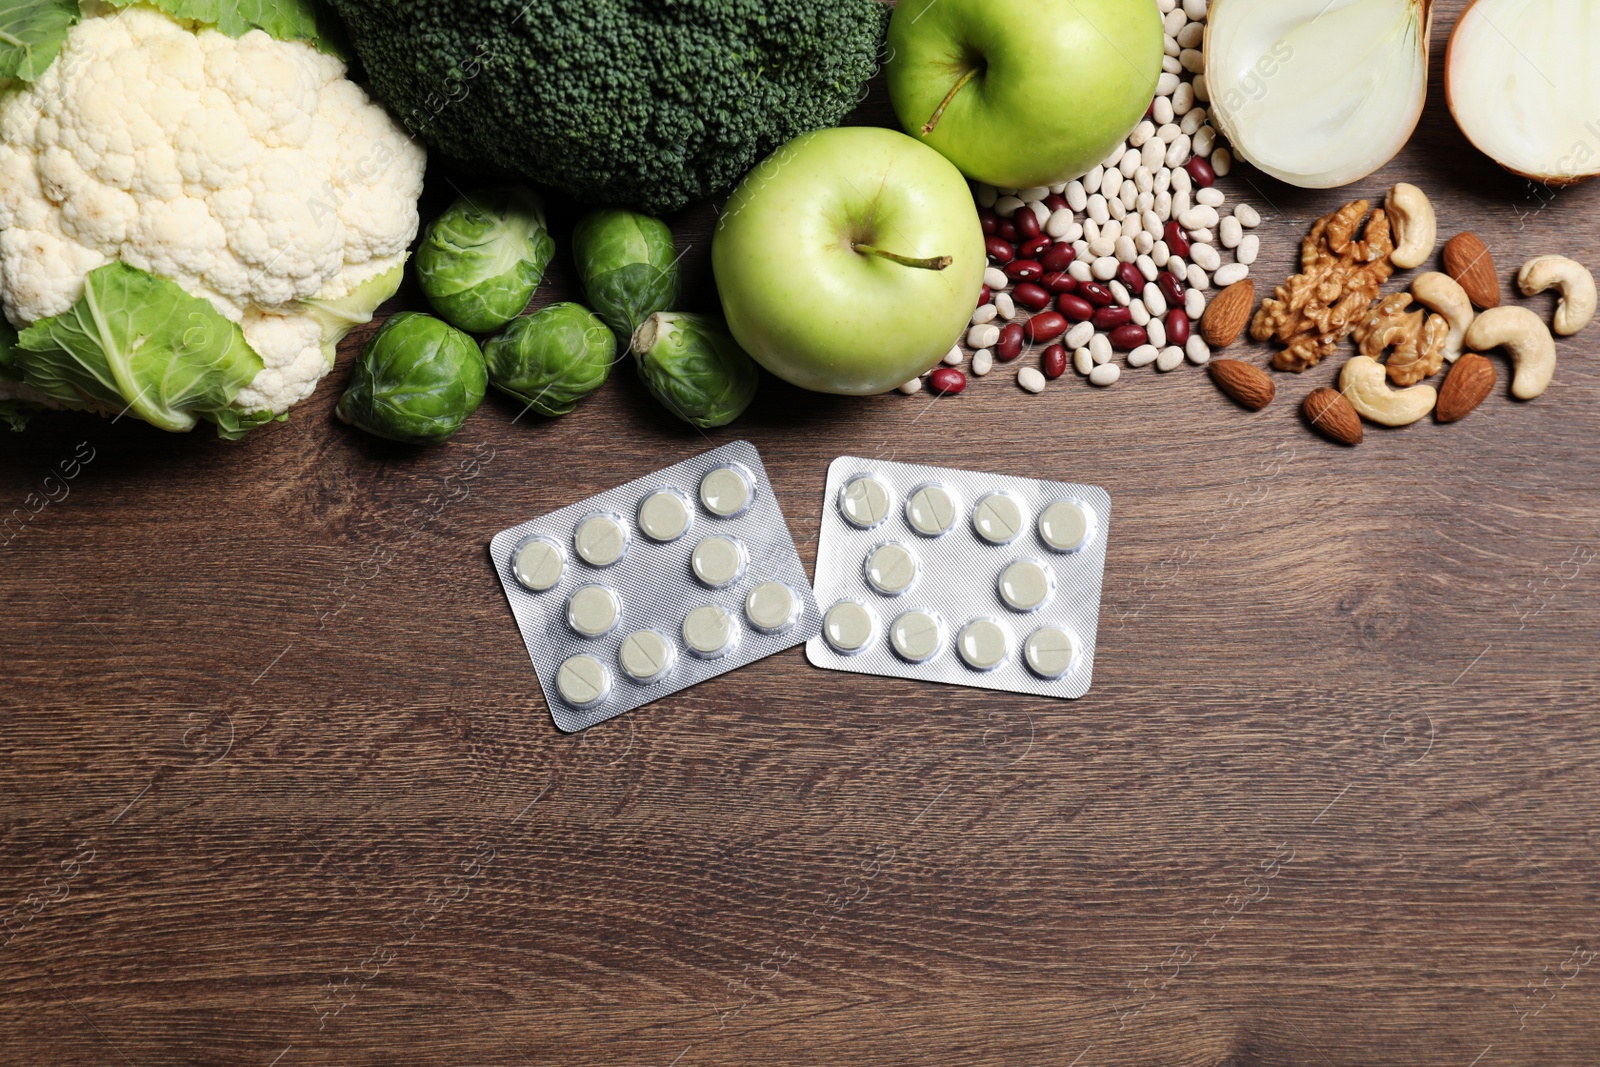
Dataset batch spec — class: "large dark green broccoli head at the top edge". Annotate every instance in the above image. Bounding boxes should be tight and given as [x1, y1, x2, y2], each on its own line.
[333, 0, 890, 214]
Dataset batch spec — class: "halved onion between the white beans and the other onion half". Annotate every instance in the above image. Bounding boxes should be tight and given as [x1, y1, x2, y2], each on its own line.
[1205, 0, 1433, 189]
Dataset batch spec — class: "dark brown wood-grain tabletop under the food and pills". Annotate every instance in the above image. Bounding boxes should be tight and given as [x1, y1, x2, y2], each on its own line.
[0, 3, 1600, 1067]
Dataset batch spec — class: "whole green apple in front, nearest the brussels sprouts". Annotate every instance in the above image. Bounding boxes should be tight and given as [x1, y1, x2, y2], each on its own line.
[710, 126, 986, 397]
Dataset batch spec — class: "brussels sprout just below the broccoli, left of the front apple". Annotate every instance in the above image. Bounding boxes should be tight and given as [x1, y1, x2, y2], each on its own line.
[573, 208, 678, 341]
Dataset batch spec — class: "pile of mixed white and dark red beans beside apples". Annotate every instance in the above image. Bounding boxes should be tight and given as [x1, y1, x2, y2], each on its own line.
[901, 0, 1261, 394]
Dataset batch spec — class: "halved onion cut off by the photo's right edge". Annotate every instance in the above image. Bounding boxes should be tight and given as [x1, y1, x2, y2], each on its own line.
[1445, 0, 1600, 186]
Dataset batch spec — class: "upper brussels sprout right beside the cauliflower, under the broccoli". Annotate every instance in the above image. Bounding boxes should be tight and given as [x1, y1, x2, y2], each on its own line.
[416, 186, 555, 333]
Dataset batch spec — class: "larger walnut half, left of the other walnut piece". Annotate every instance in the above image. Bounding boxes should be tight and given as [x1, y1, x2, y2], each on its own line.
[1250, 200, 1394, 371]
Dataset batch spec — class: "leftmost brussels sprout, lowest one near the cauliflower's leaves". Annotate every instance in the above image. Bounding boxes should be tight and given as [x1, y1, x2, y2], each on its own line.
[336, 312, 488, 445]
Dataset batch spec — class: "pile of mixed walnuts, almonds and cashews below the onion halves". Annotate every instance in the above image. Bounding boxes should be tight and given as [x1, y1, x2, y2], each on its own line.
[1206, 184, 1597, 445]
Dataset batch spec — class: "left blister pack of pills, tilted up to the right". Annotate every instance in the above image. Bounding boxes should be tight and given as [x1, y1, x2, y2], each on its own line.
[490, 442, 822, 731]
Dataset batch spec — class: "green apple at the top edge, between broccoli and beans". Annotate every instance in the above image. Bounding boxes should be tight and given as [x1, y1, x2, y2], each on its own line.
[885, 0, 1165, 189]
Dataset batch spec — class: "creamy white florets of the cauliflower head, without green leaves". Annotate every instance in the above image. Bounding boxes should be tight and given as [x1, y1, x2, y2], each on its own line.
[0, 8, 426, 414]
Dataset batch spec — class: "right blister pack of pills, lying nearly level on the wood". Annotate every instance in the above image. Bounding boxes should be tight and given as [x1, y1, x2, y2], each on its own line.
[806, 456, 1110, 699]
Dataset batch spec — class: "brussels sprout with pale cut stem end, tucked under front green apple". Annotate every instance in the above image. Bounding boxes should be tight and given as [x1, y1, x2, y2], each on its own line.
[634, 312, 758, 430]
